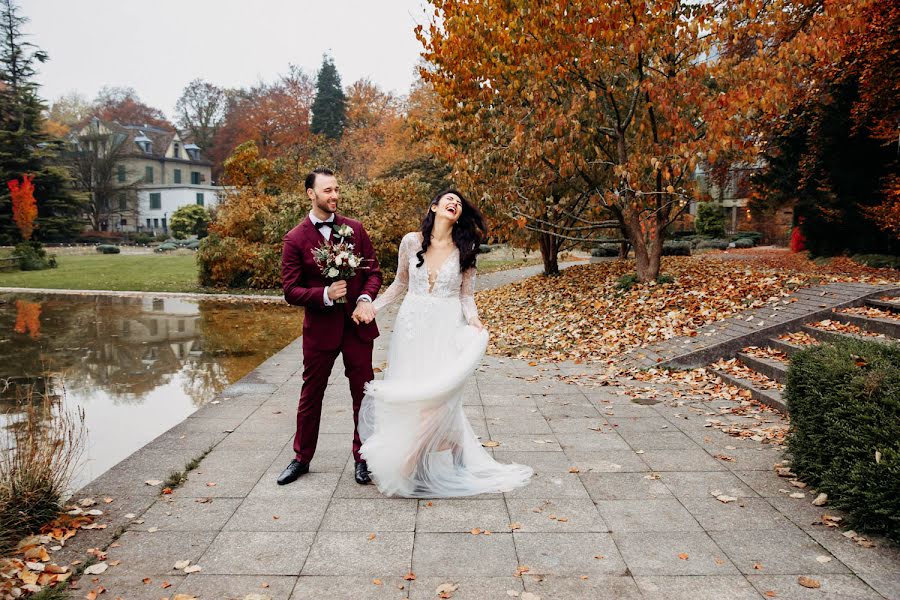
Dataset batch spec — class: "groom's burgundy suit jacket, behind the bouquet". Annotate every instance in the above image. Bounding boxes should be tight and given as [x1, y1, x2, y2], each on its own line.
[281, 214, 382, 350]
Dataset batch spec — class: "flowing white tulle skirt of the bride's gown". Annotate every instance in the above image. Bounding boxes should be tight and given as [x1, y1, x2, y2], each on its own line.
[359, 294, 533, 497]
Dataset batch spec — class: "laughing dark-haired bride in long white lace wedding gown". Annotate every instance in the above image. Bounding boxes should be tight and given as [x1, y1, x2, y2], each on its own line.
[359, 190, 533, 497]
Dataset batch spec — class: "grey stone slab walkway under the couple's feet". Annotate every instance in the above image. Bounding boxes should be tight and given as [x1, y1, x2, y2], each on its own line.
[67, 264, 900, 600]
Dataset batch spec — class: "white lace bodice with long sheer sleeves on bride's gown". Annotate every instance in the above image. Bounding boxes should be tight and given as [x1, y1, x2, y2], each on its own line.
[374, 232, 478, 323]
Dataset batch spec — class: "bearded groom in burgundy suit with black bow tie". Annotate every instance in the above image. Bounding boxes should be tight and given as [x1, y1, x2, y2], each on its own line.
[278, 167, 381, 485]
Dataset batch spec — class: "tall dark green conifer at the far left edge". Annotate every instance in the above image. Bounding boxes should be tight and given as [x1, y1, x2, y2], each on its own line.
[0, 0, 81, 244]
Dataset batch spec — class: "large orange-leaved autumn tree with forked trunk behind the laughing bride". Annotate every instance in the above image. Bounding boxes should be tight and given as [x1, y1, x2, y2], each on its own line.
[417, 0, 874, 281]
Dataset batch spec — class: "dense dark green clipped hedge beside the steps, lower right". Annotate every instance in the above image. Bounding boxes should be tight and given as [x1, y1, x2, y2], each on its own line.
[784, 340, 900, 542]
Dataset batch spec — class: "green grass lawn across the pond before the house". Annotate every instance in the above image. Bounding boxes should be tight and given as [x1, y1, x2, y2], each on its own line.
[0, 254, 206, 292]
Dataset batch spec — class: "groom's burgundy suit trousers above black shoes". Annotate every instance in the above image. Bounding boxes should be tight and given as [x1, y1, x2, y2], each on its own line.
[294, 317, 375, 463]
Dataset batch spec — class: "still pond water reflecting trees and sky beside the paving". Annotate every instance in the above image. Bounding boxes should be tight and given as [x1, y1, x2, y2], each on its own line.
[0, 294, 303, 489]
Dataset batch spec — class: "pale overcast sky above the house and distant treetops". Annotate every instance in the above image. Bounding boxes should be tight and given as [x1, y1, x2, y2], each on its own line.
[28, 0, 430, 118]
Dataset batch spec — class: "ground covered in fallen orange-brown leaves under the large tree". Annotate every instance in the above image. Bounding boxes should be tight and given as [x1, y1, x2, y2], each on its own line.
[477, 250, 900, 361]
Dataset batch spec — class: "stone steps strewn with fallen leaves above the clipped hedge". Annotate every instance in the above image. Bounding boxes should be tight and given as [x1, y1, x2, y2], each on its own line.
[711, 290, 900, 412]
